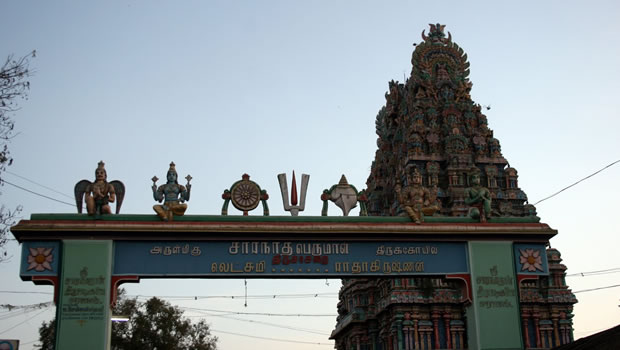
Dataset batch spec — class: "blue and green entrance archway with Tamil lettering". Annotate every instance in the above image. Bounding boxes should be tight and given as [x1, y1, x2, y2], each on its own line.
[12, 214, 556, 349]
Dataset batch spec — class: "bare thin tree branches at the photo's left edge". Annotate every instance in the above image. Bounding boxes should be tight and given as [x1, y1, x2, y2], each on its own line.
[0, 51, 36, 262]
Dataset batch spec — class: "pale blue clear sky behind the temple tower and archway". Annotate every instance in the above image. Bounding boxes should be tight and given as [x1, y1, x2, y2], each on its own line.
[0, 0, 620, 349]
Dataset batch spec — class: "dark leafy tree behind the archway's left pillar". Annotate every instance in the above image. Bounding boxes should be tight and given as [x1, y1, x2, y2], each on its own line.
[39, 291, 217, 350]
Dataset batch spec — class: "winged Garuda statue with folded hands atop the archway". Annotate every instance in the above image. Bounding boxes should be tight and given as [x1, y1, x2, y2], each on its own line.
[74, 161, 125, 216]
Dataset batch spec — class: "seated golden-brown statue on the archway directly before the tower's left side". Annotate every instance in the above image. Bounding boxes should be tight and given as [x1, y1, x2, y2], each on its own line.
[395, 168, 438, 224]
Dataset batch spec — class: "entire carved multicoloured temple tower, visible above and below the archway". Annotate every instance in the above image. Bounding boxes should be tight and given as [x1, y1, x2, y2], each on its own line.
[331, 24, 577, 350]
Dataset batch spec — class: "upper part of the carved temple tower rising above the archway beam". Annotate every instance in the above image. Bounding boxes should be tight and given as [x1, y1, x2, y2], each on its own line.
[366, 24, 535, 216]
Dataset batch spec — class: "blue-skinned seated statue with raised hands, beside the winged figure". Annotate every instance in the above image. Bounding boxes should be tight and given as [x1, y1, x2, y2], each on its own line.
[151, 162, 192, 221]
